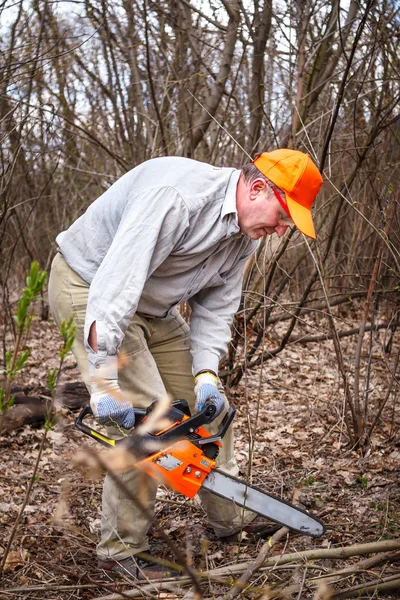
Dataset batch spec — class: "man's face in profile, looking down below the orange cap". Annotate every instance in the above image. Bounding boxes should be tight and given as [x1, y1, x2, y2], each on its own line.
[237, 179, 293, 240]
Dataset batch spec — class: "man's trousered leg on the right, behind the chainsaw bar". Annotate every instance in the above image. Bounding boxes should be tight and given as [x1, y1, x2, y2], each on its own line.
[148, 310, 256, 537]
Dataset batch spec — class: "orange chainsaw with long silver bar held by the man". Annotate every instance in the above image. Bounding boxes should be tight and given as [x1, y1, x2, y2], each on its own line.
[75, 400, 325, 537]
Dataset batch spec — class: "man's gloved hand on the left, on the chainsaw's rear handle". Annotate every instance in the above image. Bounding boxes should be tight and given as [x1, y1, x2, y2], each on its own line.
[90, 379, 135, 429]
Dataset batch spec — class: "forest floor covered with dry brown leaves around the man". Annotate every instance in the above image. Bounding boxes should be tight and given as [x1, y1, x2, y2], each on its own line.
[0, 316, 400, 600]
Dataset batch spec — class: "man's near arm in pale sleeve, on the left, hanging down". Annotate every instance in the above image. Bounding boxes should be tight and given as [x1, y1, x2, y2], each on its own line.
[85, 188, 188, 377]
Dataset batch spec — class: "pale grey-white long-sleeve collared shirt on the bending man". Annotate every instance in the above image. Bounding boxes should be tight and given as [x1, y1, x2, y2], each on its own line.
[57, 157, 257, 376]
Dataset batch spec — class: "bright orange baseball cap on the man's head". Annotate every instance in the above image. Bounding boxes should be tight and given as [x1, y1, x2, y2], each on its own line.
[253, 148, 323, 240]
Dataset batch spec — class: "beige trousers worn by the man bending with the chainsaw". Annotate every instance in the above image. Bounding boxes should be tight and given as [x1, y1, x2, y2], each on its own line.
[49, 253, 255, 560]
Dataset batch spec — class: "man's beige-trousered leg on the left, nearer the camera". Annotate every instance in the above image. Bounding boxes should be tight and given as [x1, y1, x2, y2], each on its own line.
[49, 254, 170, 560]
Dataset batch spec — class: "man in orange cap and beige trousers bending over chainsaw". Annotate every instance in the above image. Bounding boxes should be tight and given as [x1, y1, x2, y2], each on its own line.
[49, 149, 322, 578]
